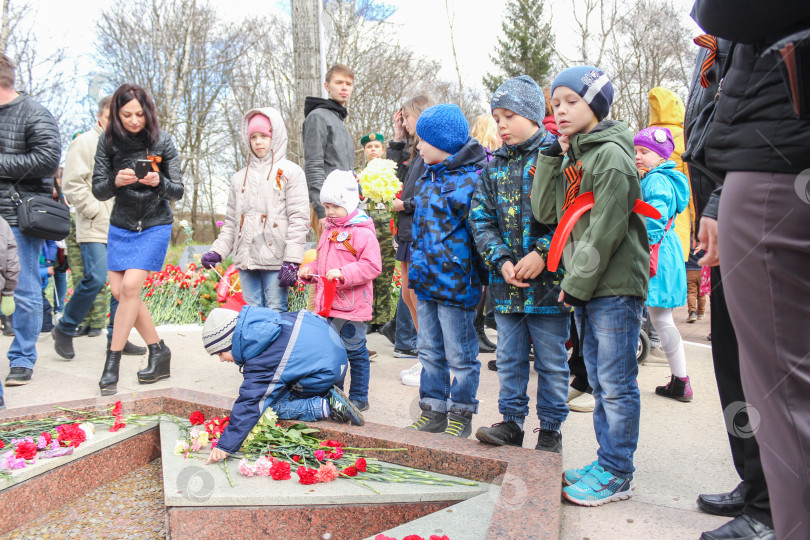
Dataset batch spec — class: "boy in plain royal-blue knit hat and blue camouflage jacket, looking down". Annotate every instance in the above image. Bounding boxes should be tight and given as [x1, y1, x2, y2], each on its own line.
[408, 105, 487, 438]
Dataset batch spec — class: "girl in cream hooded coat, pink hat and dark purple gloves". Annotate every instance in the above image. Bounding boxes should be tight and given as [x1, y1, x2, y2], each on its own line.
[201, 107, 309, 311]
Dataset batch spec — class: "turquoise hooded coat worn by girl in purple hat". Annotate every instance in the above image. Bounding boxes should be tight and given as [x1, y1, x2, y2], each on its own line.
[641, 161, 689, 308]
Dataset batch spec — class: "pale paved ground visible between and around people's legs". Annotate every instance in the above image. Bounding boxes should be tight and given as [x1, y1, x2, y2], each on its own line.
[0, 309, 739, 540]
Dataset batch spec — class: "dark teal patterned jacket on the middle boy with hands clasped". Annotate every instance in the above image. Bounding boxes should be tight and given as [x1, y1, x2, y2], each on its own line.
[470, 128, 569, 314]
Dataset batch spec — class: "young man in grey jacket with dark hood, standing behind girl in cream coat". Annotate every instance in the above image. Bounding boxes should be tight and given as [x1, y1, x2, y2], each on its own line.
[303, 64, 354, 227]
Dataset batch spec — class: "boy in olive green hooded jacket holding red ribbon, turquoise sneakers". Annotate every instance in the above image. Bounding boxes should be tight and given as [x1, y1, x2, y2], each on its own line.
[531, 66, 650, 506]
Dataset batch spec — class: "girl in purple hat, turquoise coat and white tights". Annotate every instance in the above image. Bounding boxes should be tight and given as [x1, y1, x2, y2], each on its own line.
[633, 127, 692, 401]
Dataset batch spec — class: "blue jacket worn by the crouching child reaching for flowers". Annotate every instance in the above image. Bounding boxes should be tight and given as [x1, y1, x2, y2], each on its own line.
[217, 306, 348, 454]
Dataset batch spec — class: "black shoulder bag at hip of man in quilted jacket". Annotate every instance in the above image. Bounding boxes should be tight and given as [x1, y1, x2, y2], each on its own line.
[9, 183, 70, 240]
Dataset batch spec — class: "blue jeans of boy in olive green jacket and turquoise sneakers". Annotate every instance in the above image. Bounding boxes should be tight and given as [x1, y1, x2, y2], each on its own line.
[575, 296, 644, 478]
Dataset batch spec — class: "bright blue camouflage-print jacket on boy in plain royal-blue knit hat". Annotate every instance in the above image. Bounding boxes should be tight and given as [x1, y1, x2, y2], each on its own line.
[408, 137, 487, 309]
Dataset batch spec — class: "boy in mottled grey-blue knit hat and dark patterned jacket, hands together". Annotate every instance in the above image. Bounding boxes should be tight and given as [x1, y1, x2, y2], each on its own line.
[470, 75, 571, 452]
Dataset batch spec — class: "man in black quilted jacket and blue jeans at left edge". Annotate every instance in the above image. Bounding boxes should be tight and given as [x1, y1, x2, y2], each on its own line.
[0, 55, 61, 386]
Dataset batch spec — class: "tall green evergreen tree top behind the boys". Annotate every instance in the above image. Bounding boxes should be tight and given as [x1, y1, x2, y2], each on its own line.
[483, 0, 554, 92]
